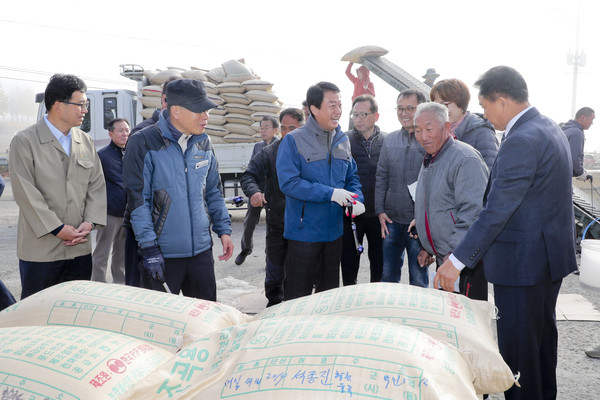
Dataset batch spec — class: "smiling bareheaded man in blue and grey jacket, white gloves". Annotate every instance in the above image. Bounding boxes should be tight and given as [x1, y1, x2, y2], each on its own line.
[277, 82, 365, 300]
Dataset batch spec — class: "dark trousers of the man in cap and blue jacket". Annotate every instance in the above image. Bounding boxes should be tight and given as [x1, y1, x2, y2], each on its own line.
[140, 248, 217, 301]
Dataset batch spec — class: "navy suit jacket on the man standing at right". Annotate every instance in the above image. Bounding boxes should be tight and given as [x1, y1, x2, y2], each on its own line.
[454, 108, 577, 286]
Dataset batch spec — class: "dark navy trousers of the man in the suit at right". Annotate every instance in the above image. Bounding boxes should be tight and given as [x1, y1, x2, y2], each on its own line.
[494, 279, 562, 400]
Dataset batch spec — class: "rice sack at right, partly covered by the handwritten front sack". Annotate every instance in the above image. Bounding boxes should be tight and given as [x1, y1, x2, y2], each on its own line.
[255, 283, 514, 393]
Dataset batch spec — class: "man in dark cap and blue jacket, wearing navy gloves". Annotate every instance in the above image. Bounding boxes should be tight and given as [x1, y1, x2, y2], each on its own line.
[123, 79, 233, 301]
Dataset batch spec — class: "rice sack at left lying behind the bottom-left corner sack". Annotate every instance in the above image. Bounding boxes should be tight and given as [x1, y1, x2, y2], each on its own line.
[0, 281, 251, 352]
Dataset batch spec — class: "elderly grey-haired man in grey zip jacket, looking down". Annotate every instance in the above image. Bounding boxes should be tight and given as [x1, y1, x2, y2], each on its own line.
[415, 103, 489, 300]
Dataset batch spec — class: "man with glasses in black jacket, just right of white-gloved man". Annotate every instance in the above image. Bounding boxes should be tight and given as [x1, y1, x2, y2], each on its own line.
[342, 95, 385, 286]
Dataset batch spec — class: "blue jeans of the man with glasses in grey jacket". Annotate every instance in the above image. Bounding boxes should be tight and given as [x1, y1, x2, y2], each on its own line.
[381, 222, 429, 287]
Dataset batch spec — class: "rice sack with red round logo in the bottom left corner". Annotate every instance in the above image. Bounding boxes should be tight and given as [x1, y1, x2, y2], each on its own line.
[0, 326, 172, 400]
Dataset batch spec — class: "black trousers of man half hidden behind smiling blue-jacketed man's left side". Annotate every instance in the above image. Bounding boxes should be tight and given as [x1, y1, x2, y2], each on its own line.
[265, 222, 287, 307]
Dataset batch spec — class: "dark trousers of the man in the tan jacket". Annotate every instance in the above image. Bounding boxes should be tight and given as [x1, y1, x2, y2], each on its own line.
[19, 254, 92, 300]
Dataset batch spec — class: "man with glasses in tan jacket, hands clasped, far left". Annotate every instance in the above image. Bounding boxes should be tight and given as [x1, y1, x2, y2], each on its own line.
[9, 74, 106, 299]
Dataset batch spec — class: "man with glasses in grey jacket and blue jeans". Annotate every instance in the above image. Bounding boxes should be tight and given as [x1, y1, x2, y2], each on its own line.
[375, 89, 429, 287]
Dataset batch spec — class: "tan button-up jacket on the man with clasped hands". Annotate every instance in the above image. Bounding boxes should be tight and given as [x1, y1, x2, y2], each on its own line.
[9, 119, 106, 262]
